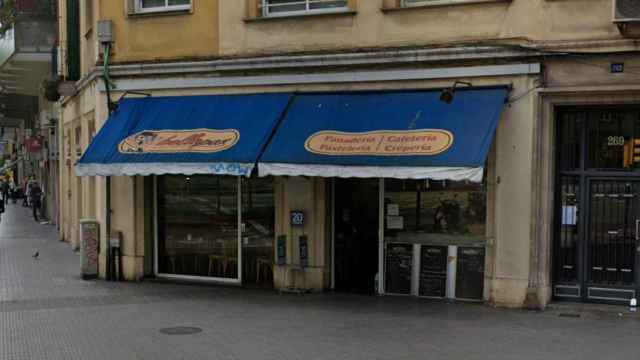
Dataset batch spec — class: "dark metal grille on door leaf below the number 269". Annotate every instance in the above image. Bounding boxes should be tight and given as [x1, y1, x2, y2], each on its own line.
[587, 180, 640, 286]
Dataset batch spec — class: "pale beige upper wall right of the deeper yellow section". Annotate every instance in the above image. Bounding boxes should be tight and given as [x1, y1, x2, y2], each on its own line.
[219, 0, 621, 55]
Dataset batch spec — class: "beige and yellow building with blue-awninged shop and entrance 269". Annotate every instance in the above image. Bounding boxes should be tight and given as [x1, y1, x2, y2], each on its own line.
[59, 0, 640, 308]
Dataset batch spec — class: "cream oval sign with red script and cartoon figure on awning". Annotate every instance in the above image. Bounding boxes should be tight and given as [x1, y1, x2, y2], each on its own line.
[118, 129, 240, 154]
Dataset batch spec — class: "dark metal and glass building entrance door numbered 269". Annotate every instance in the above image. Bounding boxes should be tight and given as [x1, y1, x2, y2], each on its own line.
[554, 108, 640, 304]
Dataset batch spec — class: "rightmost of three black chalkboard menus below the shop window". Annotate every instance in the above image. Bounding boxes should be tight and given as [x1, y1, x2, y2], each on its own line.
[456, 247, 484, 300]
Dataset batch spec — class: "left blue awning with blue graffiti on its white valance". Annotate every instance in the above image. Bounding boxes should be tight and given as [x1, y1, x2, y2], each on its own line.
[76, 93, 292, 176]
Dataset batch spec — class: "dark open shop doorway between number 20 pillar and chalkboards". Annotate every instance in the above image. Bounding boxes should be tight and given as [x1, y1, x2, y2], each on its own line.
[334, 179, 379, 294]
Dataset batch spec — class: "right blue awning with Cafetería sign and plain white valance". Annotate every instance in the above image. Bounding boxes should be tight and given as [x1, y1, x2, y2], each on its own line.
[258, 87, 509, 182]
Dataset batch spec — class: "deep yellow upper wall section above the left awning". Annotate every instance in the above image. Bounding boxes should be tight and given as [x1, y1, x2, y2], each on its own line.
[100, 0, 220, 62]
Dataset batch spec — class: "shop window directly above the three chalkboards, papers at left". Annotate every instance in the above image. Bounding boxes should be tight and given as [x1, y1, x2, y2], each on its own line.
[384, 179, 487, 241]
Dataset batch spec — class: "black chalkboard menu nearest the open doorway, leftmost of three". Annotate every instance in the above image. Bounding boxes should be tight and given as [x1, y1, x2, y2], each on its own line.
[385, 243, 413, 294]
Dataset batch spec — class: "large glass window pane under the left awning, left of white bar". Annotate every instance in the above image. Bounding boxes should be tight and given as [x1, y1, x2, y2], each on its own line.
[158, 175, 238, 279]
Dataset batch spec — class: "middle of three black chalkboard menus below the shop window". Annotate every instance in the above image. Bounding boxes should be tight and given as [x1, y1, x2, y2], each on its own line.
[419, 246, 448, 298]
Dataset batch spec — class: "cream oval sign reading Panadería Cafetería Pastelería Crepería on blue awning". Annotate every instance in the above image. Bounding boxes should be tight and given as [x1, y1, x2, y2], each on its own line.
[305, 129, 454, 156]
